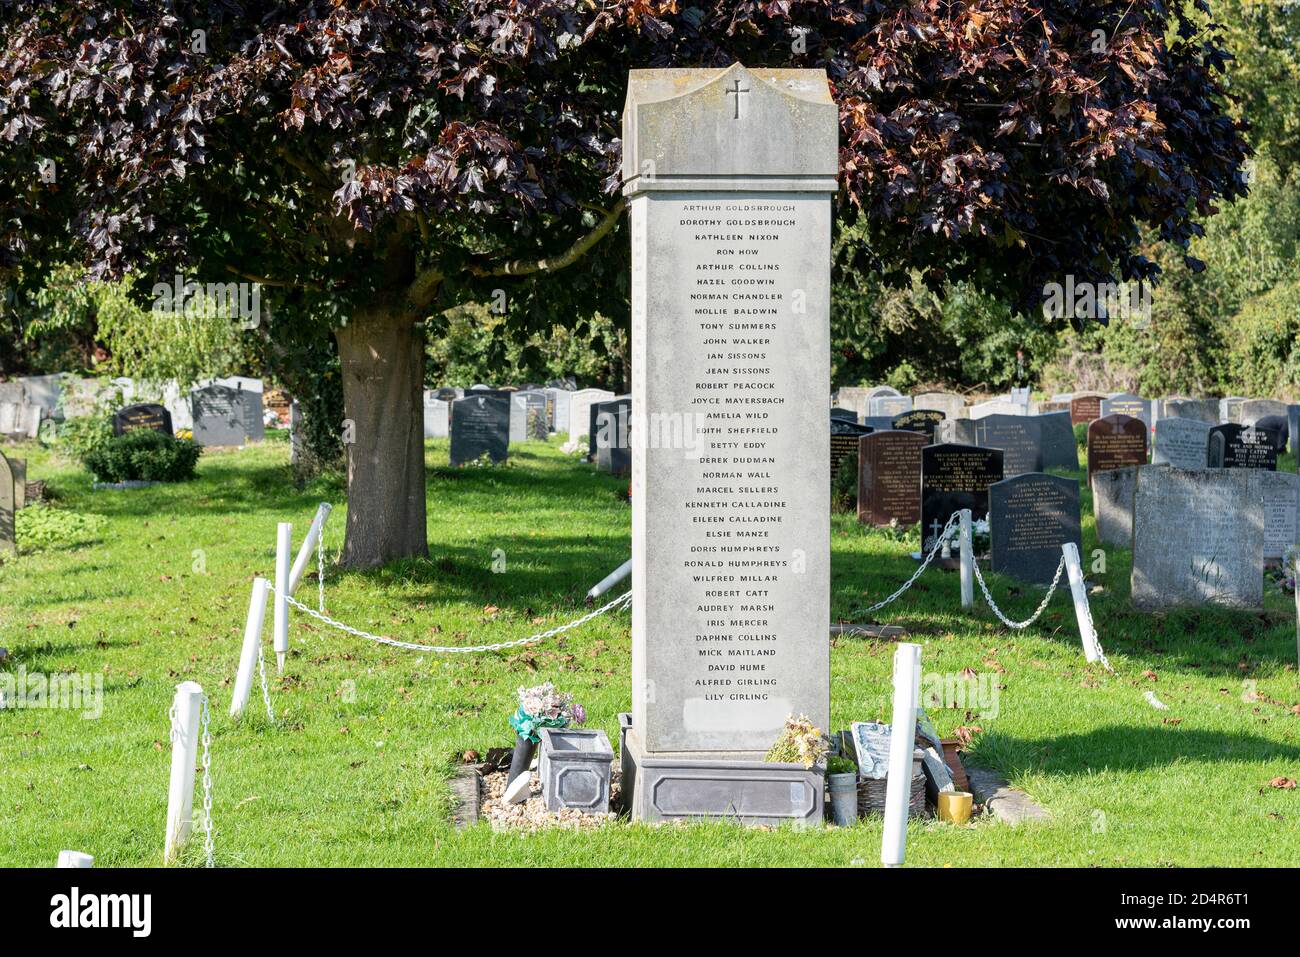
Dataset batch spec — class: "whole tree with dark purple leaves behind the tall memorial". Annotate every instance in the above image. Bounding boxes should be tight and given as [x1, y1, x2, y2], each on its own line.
[0, 0, 1248, 566]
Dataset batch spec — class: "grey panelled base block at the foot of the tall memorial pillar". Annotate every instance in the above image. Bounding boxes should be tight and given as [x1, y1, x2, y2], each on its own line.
[619, 714, 824, 827]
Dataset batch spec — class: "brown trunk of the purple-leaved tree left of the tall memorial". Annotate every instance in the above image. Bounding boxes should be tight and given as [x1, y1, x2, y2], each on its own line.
[334, 309, 429, 568]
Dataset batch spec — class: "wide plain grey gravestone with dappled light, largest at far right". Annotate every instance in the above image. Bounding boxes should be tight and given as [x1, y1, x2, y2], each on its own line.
[1132, 467, 1264, 611]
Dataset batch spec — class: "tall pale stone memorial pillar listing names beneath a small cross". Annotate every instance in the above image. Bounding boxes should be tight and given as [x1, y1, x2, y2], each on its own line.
[621, 64, 832, 824]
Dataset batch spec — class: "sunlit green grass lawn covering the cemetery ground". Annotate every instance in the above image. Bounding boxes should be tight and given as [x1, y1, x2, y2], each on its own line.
[0, 438, 1300, 866]
